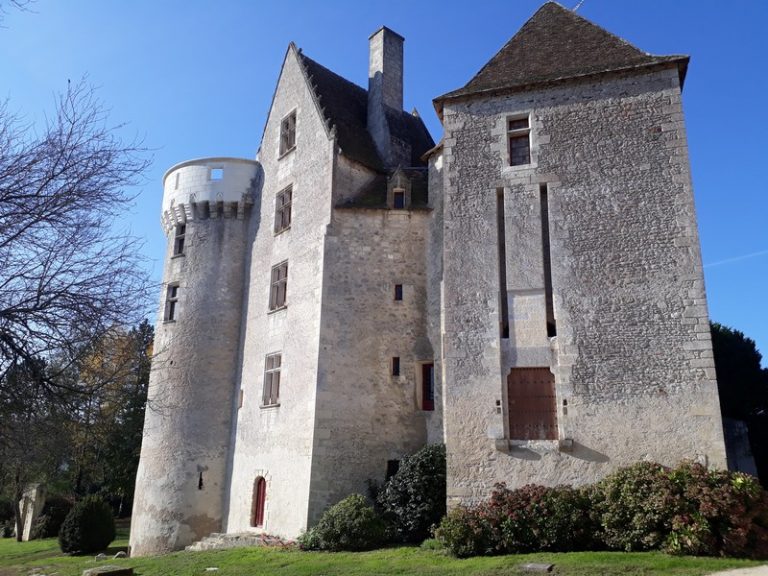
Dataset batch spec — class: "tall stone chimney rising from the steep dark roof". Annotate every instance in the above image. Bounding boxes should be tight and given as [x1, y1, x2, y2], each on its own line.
[368, 26, 405, 166]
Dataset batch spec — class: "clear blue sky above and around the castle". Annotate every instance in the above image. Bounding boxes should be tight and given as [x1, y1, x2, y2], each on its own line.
[0, 0, 768, 365]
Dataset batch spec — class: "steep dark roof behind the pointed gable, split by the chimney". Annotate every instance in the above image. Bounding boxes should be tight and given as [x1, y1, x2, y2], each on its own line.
[299, 52, 434, 171]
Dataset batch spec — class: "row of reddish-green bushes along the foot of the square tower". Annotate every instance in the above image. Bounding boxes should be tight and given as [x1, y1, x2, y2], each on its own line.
[435, 462, 768, 558]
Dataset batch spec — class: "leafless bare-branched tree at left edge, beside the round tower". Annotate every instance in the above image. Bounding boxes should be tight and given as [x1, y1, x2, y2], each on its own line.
[0, 82, 149, 526]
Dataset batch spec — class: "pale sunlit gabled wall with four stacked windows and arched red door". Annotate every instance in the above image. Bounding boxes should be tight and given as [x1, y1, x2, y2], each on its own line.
[226, 48, 334, 537]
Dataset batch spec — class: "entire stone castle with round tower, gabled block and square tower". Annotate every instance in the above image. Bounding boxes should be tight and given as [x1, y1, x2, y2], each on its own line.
[131, 2, 726, 555]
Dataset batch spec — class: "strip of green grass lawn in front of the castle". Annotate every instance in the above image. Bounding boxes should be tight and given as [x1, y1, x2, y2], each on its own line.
[0, 530, 759, 576]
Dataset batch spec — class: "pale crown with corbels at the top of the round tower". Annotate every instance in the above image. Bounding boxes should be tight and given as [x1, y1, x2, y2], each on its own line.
[162, 158, 260, 235]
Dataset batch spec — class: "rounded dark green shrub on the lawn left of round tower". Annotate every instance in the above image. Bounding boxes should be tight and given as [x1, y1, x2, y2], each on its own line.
[59, 496, 115, 554]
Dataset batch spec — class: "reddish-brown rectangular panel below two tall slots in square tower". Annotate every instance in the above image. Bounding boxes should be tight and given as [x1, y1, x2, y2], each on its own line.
[507, 368, 557, 440]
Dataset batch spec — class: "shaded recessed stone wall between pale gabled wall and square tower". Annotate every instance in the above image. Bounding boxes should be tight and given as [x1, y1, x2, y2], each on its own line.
[310, 183, 439, 523]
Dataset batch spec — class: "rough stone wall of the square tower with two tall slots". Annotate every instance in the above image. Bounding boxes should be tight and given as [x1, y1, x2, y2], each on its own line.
[442, 70, 726, 502]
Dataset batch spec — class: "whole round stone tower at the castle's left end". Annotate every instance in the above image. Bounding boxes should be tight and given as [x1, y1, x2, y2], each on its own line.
[130, 158, 261, 556]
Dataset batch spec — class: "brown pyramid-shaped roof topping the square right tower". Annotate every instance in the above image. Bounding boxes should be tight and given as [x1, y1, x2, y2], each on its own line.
[435, 2, 688, 110]
